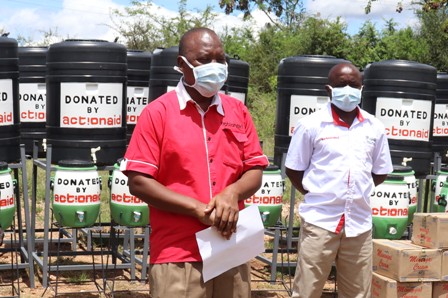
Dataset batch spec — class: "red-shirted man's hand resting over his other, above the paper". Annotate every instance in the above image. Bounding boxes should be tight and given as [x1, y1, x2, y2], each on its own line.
[205, 188, 239, 239]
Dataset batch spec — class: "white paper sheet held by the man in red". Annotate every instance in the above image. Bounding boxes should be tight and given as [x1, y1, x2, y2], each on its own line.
[196, 205, 264, 282]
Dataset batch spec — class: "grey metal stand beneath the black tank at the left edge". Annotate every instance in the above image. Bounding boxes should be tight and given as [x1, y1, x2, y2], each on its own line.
[0, 144, 34, 288]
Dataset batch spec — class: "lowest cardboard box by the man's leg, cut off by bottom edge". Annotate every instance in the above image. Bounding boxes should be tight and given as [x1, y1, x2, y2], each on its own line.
[372, 272, 432, 298]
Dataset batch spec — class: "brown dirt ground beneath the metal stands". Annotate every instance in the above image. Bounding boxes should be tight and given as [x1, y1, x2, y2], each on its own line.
[0, 168, 337, 298]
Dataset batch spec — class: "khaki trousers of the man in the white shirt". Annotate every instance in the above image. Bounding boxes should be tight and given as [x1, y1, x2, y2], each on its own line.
[292, 220, 372, 298]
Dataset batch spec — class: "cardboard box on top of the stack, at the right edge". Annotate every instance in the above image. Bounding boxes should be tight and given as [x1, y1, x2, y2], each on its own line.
[411, 213, 448, 248]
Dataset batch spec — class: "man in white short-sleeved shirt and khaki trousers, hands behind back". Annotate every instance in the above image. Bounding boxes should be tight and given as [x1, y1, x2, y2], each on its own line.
[285, 63, 393, 298]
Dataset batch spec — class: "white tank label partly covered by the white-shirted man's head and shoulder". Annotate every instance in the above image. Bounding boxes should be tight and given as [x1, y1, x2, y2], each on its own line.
[289, 95, 330, 136]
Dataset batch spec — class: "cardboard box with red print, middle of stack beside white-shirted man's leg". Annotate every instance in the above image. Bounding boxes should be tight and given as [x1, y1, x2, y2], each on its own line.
[373, 239, 442, 282]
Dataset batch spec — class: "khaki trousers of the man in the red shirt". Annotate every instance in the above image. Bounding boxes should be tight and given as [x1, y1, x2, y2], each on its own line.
[149, 263, 251, 298]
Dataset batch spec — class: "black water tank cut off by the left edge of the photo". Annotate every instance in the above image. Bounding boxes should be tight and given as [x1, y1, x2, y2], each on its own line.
[0, 35, 20, 162]
